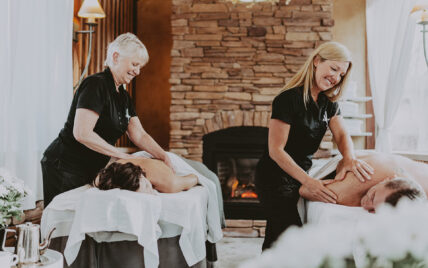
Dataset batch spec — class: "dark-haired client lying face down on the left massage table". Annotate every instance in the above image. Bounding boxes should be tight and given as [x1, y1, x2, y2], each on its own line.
[93, 158, 198, 193]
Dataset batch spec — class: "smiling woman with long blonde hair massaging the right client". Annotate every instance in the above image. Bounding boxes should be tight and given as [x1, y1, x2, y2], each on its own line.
[256, 42, 373, 250]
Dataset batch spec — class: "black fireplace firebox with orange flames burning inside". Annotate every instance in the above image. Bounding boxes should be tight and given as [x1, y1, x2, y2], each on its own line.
[202, 126, 268, 219]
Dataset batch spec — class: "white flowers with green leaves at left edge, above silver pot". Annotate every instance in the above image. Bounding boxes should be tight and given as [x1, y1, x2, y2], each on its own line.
[0, 168, 29, 229]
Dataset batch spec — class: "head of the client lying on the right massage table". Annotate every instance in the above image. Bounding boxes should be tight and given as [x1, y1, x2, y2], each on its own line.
[361, 177, 426, 212]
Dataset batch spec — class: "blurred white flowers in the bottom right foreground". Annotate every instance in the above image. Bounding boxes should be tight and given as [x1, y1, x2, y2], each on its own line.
[240, 200, 428, 268]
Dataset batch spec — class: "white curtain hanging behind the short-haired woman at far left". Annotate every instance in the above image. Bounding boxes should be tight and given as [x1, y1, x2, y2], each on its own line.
[0, 0, 73, 209]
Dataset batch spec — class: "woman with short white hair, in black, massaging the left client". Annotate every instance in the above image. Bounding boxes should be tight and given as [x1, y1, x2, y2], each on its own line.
[41, 33, 172, 206]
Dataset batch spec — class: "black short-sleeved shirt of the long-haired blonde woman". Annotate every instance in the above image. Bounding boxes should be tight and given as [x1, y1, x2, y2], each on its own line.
[262, 87, 340, 178]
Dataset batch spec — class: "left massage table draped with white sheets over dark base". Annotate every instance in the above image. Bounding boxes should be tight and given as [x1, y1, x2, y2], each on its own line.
[42, 152, 224, 268]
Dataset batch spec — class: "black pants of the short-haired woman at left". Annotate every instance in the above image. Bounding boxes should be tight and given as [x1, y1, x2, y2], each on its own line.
[40, 156, 89, 207]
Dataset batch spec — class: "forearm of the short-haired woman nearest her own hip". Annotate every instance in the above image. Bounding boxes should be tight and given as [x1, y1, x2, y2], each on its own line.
[74, 131, 131, 159]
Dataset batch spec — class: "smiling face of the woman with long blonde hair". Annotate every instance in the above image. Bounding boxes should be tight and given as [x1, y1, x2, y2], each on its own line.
[314, 56, 349, 91]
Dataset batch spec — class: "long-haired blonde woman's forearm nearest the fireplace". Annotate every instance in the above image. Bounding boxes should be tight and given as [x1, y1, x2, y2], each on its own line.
[269, 149, 312, 184]
